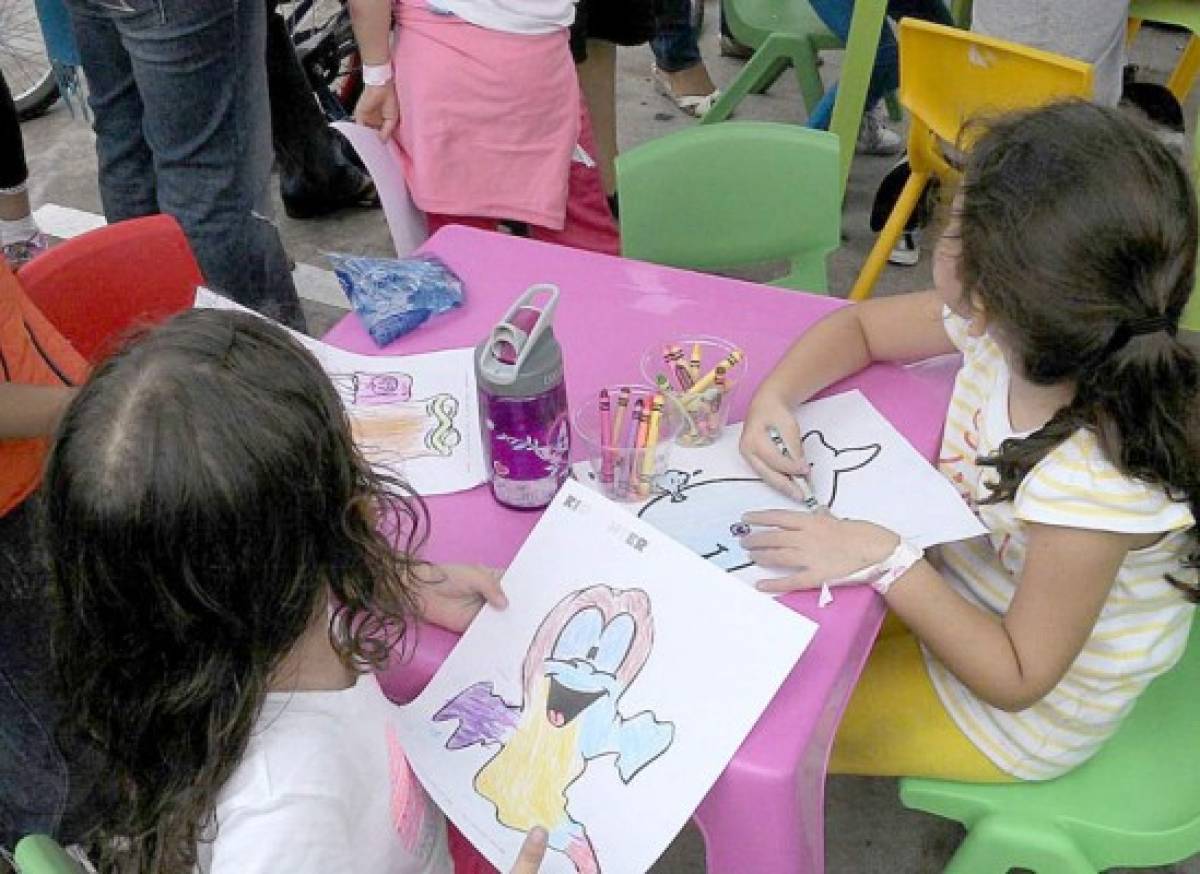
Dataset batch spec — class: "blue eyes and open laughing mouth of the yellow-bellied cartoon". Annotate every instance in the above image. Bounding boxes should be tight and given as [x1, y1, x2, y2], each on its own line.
[546, 607, 636, 729]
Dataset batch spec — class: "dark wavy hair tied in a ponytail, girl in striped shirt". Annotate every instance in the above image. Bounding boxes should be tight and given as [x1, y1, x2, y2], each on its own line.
[958, 101, 1200, 600]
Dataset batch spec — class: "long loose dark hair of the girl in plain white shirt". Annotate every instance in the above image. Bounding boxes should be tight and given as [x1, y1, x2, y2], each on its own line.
[42, 310, 427, 874]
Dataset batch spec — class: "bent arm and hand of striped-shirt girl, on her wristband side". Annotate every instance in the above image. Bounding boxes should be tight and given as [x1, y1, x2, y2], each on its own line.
[744, 511, 1137, 711]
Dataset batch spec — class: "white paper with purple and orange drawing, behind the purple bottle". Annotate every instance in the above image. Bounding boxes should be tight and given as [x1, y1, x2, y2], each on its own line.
[196, 288, 486, 495]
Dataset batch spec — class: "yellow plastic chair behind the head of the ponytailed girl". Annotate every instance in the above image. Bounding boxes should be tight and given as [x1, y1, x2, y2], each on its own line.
[850, 18, 1092, 300]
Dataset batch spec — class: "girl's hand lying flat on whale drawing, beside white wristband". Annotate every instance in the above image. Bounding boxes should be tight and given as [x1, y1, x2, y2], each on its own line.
[742, 510, 900, 592]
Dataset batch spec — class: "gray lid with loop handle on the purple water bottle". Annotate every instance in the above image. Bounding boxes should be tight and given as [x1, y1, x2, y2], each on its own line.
[475, 282, 563, 397]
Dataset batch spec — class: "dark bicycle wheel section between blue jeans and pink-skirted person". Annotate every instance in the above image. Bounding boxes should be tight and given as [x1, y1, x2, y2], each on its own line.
[278, 0, 362, 121]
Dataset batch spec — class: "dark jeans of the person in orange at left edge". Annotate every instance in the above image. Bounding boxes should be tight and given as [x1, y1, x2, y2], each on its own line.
[0, 501, 108, 850]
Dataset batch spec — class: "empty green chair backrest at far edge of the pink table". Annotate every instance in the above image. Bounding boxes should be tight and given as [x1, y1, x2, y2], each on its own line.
[617, 121, 841, 292]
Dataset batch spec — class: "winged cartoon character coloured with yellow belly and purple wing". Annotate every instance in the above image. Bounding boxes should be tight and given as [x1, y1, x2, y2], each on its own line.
[433, 586, 674, 874]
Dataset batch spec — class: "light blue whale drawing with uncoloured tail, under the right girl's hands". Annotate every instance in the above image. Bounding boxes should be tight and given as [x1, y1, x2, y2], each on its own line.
[637, 431, 881, 573]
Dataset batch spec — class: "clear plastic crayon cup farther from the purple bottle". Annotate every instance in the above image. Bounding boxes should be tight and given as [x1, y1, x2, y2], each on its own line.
[642, 336, 746, 447]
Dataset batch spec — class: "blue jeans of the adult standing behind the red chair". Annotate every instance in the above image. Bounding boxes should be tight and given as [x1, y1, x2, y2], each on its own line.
[67, 0, 304, 329]
